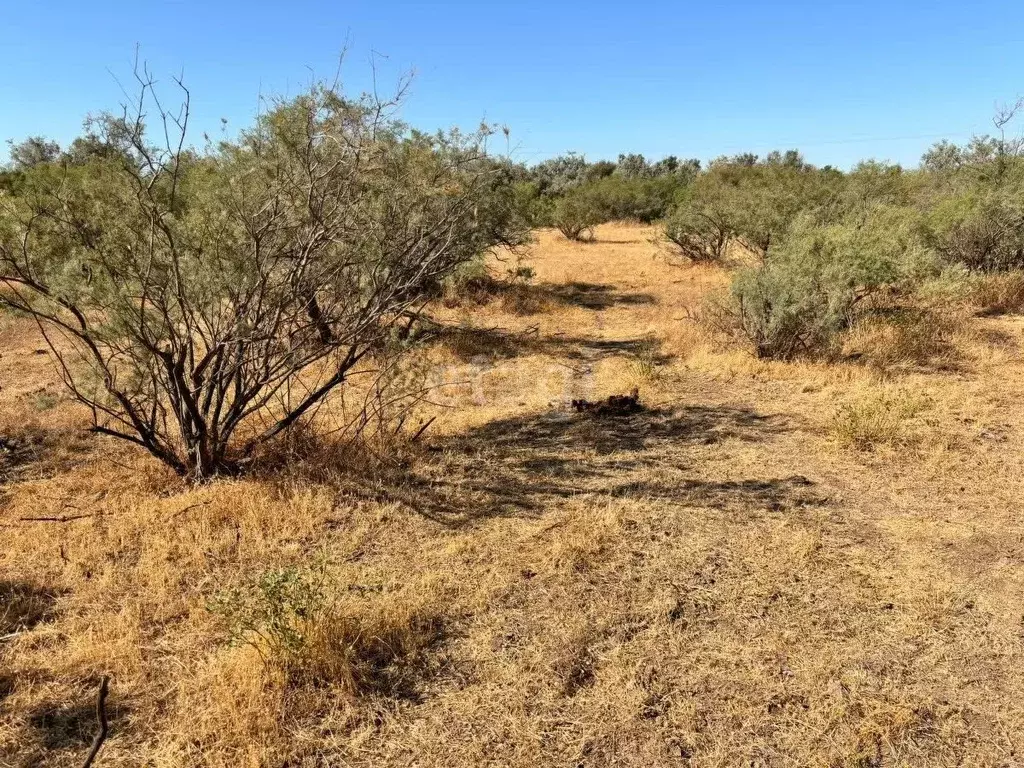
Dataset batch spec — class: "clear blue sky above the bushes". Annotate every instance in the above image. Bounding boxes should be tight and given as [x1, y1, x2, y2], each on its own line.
[0, 0, 1024, 167]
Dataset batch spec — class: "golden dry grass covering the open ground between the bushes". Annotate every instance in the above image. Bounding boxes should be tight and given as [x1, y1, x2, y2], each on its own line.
[0, 225, 1024, 768]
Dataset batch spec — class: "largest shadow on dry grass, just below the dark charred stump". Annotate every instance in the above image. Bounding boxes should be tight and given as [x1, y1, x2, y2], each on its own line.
[337, 406, 798, 526]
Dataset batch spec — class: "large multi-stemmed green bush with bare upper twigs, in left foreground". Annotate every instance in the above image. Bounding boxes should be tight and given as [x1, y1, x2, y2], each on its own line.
[0, 76, 521, 477]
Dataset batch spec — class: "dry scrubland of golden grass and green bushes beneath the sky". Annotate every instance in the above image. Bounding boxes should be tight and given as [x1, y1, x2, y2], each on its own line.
[6, 52, 1024, 768]
